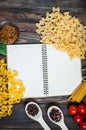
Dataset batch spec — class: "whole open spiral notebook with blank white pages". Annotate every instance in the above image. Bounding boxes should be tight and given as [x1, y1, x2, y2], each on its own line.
[7, 44, 82, 98]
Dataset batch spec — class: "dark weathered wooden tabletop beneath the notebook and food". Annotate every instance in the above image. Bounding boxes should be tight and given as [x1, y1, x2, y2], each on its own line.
[0, 0, 86, 130]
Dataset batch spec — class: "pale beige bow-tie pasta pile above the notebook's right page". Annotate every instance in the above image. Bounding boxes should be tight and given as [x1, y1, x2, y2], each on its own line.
[36, 7, 86, 59]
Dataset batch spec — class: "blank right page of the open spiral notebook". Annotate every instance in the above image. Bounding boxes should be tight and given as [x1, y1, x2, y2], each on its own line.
[47, 46, 82, 95]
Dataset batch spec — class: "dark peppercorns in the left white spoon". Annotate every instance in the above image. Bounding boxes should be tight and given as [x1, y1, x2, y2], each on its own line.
[27, 104, 39, 116]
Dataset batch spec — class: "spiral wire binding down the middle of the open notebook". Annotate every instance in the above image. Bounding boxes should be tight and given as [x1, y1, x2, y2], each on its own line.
[41, 45, 49, 96]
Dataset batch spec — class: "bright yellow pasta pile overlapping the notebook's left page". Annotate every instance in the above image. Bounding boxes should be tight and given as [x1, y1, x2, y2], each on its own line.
[0, 59, 25, 118]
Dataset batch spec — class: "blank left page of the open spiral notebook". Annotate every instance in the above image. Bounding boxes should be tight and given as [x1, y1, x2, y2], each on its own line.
[7, 45, 44, 97]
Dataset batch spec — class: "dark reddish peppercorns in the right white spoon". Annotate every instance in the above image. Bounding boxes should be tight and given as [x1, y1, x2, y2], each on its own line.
[50, 108, 62, 122]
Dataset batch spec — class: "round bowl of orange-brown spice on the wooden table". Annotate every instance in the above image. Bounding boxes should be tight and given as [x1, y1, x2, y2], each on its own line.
[0, 22, 19, 44]
